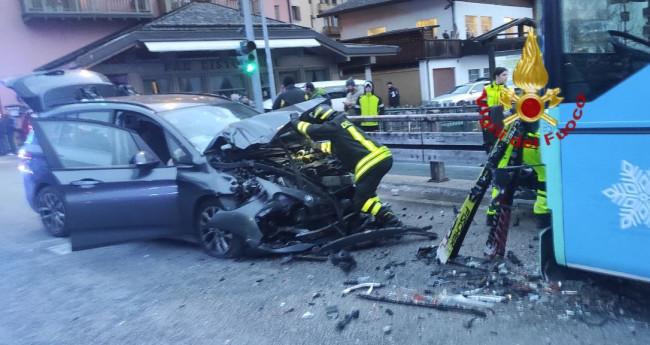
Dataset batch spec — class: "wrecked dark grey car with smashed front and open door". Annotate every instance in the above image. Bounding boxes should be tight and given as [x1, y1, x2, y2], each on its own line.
[6, 71, 394, 257]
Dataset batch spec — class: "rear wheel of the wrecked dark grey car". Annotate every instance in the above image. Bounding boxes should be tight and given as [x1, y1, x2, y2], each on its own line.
[36, 187, 69, 237]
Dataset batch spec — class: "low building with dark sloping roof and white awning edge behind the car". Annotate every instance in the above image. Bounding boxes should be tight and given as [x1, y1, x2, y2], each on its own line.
[30, 2, 398, 98]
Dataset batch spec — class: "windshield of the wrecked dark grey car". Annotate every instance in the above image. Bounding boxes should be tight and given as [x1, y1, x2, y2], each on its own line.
[160, 103, 258, 152]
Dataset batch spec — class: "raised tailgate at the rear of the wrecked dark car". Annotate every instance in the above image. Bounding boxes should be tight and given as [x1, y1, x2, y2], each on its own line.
[2, 70, 118, 112]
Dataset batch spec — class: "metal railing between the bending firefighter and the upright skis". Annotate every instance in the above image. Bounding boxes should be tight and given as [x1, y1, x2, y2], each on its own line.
[349, 107, 487, 166]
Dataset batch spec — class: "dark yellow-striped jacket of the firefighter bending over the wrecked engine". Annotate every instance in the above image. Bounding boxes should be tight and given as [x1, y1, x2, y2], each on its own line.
[296, 110, 392, 181]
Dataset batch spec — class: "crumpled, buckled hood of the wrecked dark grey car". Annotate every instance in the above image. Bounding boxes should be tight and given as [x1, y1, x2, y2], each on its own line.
[203, 99, 324, 154]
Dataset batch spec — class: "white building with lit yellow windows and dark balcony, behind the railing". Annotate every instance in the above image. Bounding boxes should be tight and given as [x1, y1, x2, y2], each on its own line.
[320, 0, 533, 105]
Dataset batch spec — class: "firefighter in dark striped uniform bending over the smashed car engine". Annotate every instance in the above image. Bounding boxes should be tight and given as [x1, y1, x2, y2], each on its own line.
[291, 104, 403, 227]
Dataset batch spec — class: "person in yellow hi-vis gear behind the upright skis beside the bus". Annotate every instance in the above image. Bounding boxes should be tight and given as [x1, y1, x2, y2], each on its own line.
[477, 67, 551, 256]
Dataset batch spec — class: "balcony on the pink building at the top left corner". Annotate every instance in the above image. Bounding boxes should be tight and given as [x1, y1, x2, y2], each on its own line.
[21, 0, 154, 21]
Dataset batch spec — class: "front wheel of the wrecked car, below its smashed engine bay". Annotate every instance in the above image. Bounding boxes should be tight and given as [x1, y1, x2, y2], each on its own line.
[195, 200, 244, 258]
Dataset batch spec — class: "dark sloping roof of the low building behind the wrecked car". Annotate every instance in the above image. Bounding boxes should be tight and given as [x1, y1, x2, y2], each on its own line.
[37, 2, 399, 70]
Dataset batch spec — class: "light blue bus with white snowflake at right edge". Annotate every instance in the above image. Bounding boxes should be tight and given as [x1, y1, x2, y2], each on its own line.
[535, 0, 650, 281]
